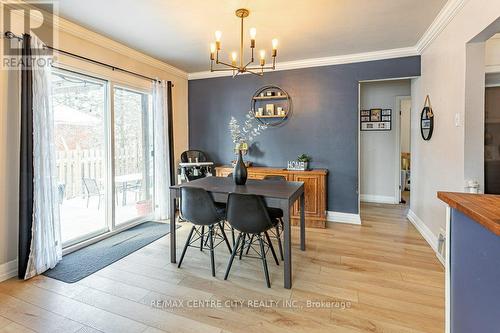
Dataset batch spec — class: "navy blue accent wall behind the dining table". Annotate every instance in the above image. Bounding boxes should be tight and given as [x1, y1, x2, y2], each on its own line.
[189, 56, 420, 213]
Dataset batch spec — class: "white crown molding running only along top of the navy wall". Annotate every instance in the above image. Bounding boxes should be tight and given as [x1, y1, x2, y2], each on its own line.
[188, 47, 418, 80]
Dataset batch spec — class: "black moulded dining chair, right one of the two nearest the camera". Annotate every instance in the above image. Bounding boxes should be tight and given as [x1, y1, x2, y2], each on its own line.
[224, 193, 279, 288]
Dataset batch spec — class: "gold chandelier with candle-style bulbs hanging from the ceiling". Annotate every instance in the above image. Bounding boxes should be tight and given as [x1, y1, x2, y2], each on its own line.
[210, 8, 278, 77]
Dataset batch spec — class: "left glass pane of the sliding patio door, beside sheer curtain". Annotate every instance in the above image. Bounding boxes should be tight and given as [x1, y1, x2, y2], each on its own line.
[52, 71, 108, 245]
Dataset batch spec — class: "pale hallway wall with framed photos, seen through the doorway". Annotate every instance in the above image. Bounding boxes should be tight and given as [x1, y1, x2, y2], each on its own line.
[360, 80, 411, 203]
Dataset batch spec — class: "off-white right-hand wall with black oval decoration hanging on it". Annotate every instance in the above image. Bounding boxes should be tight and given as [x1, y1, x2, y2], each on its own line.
[410, 0, 500, 245]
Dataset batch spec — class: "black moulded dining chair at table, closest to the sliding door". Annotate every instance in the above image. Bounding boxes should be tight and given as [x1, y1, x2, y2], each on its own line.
[178, 186, 232, 276]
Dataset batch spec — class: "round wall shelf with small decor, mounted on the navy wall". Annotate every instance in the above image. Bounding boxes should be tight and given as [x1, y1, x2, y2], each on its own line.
[251, 85, 292, 126]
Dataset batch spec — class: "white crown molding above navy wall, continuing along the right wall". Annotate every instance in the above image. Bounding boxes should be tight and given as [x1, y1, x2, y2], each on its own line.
[188, 0, 467, 80]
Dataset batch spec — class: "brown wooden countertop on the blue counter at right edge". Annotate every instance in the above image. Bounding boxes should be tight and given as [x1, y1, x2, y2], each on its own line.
[438, 192, 500, 236]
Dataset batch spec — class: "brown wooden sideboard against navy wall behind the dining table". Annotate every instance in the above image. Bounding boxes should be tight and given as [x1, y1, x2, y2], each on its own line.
[215, 166, 328, 228]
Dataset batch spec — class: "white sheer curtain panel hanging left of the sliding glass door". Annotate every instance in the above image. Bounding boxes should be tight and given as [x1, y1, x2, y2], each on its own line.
[25, 36, 62, 279]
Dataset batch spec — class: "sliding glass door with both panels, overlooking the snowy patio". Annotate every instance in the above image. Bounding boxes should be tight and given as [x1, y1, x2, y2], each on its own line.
[52, 70, 154, 247]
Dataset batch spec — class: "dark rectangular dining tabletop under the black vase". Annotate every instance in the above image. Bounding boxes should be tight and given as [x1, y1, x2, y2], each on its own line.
[170, 177, 304, 200]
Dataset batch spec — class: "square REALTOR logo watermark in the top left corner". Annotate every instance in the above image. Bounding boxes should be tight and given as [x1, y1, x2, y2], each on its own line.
[0, 0, 54, 55]
